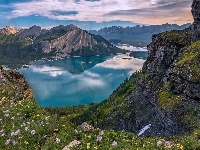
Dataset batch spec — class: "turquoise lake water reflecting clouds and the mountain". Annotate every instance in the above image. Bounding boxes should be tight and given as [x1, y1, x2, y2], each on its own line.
[18, 54, 144, 107]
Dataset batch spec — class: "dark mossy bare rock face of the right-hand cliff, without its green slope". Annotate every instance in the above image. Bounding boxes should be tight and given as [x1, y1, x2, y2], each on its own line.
[123, 0, 200, 136]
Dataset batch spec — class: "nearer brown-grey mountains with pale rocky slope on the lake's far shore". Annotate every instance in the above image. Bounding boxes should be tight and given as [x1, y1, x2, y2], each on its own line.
[0, 24, 125, 68]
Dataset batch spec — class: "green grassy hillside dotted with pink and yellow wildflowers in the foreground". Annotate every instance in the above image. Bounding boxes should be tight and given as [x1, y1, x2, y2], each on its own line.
[0, 68, 200, 150]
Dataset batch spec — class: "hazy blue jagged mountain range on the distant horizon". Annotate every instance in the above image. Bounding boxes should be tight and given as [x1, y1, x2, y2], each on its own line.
[89, 23, 191, 47]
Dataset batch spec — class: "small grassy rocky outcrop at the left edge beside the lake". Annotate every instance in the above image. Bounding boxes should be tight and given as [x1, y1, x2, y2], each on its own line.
[0, 66, 33, 106]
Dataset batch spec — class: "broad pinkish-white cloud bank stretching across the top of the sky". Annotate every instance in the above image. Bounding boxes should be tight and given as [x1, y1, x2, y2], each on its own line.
[1, 0, 192, 24]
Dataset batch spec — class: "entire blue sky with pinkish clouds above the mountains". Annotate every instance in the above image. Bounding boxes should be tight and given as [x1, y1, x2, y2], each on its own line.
[0, 0, 193, 29]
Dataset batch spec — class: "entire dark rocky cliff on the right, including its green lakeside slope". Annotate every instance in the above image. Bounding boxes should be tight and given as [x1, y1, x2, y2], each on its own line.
[76, 0, 200, 136]
